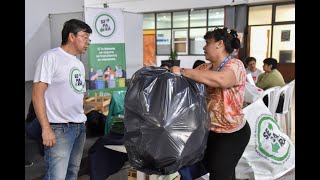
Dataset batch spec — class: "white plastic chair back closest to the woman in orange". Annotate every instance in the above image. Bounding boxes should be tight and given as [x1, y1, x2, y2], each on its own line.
[260, 86, 281, 117]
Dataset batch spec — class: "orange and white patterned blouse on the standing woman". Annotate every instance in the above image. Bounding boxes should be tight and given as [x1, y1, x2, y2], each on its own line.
[196, 59, 246, 133]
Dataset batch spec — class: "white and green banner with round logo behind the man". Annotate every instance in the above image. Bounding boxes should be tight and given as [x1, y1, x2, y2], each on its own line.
[84, 8, 126, 96]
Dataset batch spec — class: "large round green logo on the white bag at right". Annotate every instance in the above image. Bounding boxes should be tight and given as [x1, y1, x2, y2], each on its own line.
[256, 115, 291, 164]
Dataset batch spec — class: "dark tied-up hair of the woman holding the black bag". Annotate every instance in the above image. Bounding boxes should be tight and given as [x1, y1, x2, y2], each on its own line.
[203, 27, 240, 54]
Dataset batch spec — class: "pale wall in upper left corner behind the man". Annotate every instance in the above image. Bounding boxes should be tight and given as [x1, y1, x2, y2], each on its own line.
[25, 0, 84, 81]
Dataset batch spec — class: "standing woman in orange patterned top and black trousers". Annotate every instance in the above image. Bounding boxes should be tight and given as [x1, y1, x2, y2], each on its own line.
[170, 27, 251, 180]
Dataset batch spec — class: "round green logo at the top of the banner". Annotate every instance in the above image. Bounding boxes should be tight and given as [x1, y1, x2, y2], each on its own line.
[95, 13, 116, 37]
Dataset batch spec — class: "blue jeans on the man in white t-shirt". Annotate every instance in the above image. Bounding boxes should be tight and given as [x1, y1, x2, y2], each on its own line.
[44, 123, 86, 180]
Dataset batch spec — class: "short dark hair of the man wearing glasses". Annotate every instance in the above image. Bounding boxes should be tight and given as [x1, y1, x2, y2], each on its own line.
[61, 19, 92, 45]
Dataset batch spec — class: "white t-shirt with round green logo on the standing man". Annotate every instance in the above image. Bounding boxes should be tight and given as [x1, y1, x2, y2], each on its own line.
[33, 47, 87, 123]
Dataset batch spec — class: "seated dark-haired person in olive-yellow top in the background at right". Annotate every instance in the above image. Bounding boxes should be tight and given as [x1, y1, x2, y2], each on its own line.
[256, 58, 286, 90]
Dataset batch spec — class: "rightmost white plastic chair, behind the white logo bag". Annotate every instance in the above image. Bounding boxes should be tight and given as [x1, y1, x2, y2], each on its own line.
[276, 80, 295, 137]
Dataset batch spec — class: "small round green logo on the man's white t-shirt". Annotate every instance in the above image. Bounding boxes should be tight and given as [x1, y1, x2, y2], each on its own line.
[70, 68, 86, 93]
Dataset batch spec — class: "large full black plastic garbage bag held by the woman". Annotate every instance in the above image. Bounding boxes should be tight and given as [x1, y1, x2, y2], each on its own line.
[124, 67, 209, 175]
